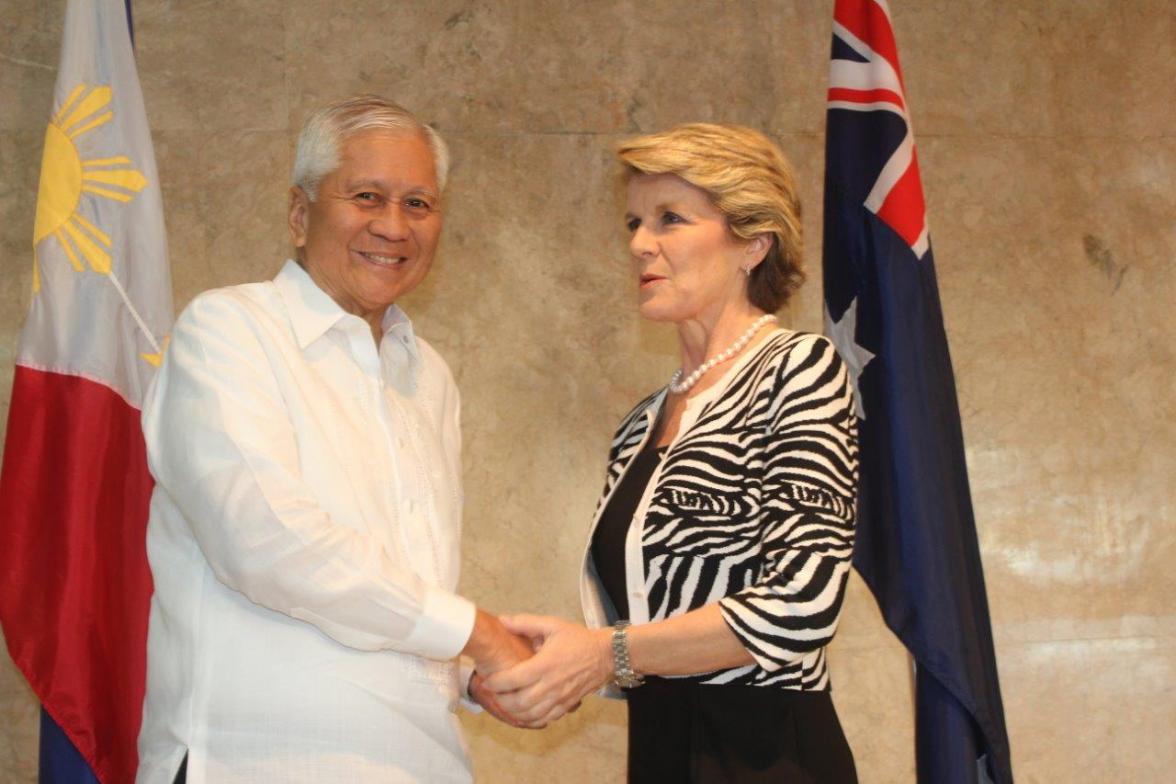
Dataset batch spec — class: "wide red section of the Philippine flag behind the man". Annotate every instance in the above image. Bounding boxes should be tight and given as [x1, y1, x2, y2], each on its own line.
[0, 366, 152, 782]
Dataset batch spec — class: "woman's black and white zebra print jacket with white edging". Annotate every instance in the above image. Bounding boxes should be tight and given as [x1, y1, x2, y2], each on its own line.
[581, 330, 857, 690]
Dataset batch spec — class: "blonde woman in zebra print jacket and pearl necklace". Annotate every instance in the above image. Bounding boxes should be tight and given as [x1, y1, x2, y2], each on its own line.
[486, 123, 857, 782]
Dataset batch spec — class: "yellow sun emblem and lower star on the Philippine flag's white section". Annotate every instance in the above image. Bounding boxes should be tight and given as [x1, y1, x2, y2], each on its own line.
[33, 85, 162, 367]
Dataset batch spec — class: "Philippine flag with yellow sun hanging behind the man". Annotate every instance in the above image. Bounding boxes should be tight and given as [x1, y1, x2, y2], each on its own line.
[0, 0, 172, 783]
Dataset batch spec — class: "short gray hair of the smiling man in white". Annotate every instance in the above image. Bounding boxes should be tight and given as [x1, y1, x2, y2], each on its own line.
[292, 95, 449, 201]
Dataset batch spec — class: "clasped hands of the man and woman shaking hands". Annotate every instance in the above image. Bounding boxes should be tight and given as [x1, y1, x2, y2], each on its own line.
[462, 610, 613, 729]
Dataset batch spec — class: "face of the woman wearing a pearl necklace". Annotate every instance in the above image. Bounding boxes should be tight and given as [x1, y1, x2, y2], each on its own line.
[624, 174, 767, 324]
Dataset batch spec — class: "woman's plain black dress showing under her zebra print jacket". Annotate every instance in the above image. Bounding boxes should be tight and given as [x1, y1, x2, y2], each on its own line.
[592, 438, 857, 784]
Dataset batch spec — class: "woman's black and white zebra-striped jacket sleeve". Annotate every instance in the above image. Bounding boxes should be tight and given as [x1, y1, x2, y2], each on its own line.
[720, 335, 857, 672]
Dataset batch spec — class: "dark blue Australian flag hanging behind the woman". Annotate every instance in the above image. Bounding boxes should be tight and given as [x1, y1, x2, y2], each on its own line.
[823, 0, 1013, 784]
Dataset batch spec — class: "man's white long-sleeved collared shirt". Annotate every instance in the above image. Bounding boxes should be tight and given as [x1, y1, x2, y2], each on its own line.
[138, 261, 475, 784]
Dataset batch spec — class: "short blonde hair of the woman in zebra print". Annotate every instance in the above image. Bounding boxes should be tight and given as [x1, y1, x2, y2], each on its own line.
[616, 122, 804, 313]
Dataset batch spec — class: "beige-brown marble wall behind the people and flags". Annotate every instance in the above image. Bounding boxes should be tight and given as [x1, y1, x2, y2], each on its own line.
[0, 0, 1176, 783]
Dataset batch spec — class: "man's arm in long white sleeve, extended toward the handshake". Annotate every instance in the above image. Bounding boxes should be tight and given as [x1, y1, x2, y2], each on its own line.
[143, 293, 475, 664]
